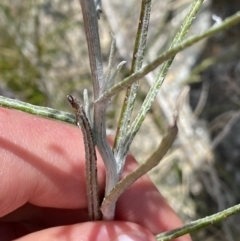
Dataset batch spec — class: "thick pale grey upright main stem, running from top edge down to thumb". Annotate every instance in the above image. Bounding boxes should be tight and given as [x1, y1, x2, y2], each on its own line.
[80, 0, 119, 220]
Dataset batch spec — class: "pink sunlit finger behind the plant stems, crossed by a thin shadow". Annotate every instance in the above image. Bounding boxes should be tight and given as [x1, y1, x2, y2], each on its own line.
[0, 108, 191, 240]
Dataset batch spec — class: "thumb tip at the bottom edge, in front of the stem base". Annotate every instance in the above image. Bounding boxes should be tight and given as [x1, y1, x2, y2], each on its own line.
[14, 221, 156, 241]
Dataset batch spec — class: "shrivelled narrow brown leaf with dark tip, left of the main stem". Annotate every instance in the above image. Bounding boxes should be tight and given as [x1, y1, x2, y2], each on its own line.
[67, 95, 101, 220]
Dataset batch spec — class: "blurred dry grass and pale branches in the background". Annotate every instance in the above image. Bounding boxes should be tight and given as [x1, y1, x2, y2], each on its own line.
[0, 0, 240, 241]
